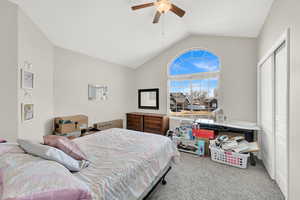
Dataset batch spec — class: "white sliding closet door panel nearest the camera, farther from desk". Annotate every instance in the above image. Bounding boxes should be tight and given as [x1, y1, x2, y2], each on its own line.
[274, 44, 288, 196]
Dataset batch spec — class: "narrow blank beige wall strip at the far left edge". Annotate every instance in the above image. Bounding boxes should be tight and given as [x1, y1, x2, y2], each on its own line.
[0, 0, 18, 141]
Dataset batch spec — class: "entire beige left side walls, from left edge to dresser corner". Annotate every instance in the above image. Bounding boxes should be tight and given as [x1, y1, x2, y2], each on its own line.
[0, 0, 135, 141]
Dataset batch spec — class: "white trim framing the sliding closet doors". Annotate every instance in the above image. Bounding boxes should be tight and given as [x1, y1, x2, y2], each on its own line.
[257, 28, 290, 200]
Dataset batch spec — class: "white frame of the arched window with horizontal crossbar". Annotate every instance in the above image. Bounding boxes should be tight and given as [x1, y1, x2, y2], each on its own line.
[167, 48, 222, 117]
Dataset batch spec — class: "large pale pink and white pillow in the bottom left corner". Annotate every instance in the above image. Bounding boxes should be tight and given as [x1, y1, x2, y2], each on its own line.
[0, 154, 92, 200]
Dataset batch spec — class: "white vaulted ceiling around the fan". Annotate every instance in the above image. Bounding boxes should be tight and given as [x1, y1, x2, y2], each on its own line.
[11, 0, 273, 68]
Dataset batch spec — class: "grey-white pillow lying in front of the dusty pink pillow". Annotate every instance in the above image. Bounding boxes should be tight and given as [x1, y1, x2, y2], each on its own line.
[18, 139, 89, 172]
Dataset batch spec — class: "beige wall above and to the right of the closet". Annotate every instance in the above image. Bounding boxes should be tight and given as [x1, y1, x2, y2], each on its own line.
[258, 0, 300, 200]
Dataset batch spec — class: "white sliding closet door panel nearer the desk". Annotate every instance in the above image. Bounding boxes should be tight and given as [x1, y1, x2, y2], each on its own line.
[259, 56, 275, 179]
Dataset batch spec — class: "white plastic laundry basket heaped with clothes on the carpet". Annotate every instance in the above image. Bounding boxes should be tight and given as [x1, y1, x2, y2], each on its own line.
[209, 145, 250, 169]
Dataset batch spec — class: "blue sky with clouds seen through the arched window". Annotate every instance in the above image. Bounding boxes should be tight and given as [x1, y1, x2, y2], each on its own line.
[170, 50, 220, 97]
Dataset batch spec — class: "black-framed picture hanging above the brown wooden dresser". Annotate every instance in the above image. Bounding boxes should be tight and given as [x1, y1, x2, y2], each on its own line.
[138, 88, 159, 110]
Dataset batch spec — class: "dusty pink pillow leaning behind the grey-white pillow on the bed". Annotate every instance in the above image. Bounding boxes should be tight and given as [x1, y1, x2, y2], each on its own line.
[44, 135, 87, 160]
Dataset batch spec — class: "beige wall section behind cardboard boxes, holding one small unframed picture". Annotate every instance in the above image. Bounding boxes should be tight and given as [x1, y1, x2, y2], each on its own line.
[54, 48, 135, 124]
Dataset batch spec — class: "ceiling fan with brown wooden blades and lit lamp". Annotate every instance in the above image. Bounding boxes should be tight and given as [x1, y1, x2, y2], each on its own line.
[131, 0, 185, 24]
